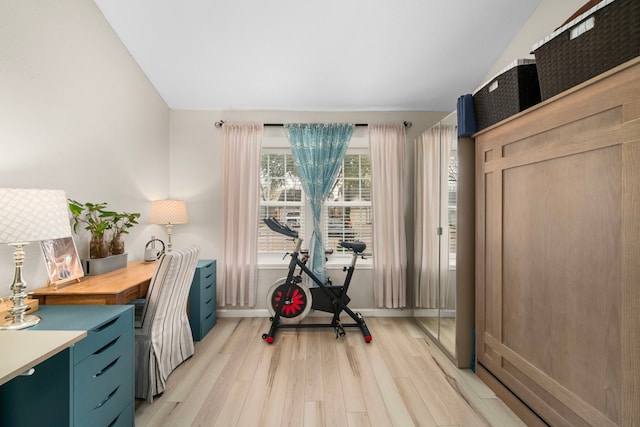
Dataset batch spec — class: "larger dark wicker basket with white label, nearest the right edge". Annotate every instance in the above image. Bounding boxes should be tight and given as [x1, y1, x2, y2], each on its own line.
[533, 0, 640, 100]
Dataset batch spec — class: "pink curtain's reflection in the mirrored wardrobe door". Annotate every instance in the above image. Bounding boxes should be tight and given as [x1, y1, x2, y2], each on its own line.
[413, 125, 457, 308]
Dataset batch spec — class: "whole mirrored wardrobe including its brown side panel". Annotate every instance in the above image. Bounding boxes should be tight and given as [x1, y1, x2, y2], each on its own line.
[413, 112, 475, 369]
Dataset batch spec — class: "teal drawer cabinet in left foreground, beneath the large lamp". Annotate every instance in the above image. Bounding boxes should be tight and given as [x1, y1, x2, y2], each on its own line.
[0, 305, 135, 426]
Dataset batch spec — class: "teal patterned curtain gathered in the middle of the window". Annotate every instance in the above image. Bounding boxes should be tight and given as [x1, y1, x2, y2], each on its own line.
[284, 123, 354, 283]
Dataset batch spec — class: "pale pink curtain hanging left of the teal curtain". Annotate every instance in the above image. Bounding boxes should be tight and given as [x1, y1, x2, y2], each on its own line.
[220, 123, 263, 307]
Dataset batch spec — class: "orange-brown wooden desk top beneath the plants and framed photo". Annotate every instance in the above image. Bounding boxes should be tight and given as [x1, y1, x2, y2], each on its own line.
[33, 260, 156, 304]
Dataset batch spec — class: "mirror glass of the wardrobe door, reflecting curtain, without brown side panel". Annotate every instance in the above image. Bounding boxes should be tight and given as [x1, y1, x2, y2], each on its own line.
[414, 112, 458, 355]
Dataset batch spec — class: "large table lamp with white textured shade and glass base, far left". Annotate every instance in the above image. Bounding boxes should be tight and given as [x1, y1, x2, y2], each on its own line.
[0, 188, 71, 330]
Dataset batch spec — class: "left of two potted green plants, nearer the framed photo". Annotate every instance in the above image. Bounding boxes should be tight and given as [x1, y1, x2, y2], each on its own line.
[69, 199, 112, 259]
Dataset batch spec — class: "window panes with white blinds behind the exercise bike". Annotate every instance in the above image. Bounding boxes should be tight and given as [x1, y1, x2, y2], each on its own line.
[258, 147, 373, 254]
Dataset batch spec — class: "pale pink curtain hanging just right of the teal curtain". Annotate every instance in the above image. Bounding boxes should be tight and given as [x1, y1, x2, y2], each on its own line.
[369, 123, 407, 308]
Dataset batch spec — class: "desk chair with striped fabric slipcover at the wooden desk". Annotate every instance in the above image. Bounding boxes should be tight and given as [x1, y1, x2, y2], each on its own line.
[135, 245, 200, 402]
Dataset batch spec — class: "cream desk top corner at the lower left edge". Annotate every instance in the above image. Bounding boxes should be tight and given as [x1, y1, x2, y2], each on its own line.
[0, 330, 87, 384]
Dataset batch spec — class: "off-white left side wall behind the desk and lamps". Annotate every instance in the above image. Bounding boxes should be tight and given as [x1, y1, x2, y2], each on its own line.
[0, 0, 169, 296]
